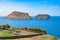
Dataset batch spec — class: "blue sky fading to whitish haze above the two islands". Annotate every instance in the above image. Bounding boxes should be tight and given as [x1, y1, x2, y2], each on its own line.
[0, 0, 60, 16]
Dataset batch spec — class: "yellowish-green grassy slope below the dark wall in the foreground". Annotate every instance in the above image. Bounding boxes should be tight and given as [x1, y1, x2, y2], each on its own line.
[10, 35, 57, 40]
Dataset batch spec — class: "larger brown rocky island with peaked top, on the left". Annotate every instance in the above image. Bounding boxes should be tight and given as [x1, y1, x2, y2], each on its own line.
[5, 11, 31, 19]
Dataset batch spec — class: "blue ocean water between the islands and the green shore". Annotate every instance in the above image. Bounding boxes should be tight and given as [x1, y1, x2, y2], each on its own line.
[0, 16, 60, 38]
